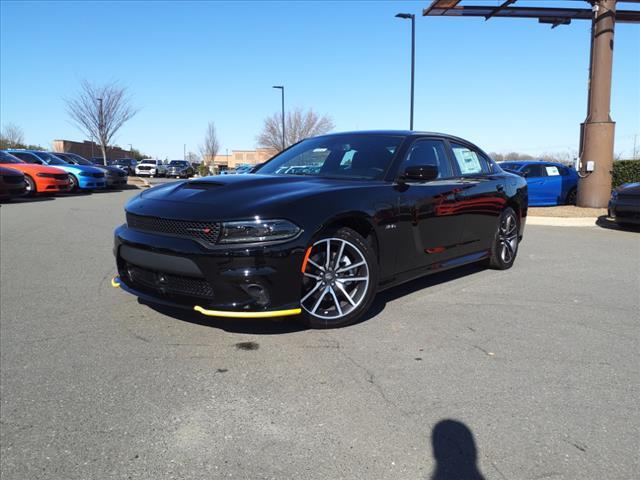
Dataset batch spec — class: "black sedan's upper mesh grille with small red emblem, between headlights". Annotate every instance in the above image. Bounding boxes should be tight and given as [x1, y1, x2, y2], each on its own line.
[127, 212, 221, 245]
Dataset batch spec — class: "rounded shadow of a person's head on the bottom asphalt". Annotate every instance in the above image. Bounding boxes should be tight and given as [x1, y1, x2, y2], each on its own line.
[429, 419, 485, 480]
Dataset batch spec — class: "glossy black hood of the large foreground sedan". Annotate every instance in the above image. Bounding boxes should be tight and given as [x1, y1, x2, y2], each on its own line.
[126, 175, 384, 220]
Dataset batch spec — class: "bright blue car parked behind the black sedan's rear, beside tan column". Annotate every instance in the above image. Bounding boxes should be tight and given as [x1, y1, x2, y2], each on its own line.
[499, 160, 580, 207]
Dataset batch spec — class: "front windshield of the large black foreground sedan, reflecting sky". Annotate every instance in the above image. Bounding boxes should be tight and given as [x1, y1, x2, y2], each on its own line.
[256, 134, 403, 180]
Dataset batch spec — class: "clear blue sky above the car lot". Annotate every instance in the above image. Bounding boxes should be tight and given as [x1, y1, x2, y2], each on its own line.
[0, 0, 640, 158]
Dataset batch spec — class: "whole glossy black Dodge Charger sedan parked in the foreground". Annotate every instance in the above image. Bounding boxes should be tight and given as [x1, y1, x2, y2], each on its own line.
[112, 131, 527, 328]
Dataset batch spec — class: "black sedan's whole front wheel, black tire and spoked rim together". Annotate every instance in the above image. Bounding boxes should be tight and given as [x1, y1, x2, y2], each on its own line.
[300, 228, 378, 328]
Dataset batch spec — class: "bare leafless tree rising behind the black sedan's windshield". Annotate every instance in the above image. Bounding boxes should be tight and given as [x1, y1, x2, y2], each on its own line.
[257, 108, 334, 152]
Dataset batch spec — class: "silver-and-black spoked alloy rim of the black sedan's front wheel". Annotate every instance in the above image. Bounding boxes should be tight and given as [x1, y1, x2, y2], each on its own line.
[300, 238, 369, 320]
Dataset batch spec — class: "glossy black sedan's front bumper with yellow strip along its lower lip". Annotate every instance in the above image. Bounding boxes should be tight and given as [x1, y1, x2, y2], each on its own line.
[114, 225, 305, 318]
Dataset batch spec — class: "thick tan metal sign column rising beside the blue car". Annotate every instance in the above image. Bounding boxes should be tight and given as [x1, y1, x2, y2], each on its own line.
[577, 0, 616, 208]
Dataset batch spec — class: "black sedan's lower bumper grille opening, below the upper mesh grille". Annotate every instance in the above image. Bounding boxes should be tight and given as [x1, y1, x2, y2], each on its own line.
[122, 263, 213, 299]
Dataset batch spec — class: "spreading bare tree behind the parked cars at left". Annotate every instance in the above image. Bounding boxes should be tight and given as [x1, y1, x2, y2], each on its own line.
[65, 80, 138, 165]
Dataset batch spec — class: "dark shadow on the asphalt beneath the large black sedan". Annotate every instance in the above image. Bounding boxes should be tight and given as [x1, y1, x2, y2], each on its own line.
[138, 264, 486, 335]
